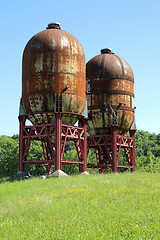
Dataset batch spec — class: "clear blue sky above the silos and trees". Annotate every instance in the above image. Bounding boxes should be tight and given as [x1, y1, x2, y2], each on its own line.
[0, 0, 160, 136]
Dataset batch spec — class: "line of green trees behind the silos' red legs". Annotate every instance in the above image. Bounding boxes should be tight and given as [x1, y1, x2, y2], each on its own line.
[0, 130, 160, 178]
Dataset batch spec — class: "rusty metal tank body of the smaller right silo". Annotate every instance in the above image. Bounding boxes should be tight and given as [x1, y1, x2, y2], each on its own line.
[86, 48, 134, 135]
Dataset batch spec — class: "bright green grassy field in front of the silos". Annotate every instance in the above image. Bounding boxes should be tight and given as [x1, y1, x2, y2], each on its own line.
[0, 173, 160, 240]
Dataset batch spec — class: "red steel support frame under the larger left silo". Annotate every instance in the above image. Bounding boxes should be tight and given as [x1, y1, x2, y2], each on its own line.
[19, 112, 88, 172]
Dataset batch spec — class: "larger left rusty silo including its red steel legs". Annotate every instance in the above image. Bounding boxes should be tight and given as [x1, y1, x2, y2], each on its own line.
[19, 23, 89, 176]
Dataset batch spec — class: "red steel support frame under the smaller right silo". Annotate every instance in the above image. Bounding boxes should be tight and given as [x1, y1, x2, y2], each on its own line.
[87, 125, 136, 173]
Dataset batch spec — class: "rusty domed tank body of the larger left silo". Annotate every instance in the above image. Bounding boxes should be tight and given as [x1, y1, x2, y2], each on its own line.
[21, 24, 86, 123]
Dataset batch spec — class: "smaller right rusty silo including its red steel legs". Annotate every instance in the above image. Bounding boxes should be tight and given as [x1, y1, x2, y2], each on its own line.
[86, 49, 135, 171]
